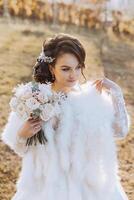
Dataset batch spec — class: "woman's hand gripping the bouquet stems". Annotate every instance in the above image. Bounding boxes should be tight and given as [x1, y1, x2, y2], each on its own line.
[18, 117, 43, 138]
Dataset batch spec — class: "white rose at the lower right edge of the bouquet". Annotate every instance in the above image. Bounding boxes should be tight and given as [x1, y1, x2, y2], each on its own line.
[40, 104, 54, 121]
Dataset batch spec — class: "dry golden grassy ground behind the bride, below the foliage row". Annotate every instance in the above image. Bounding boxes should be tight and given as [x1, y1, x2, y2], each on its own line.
[0, 18, 134, 200]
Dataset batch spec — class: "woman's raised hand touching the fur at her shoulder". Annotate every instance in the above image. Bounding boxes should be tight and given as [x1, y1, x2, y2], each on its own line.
[92, 77, 120, 93]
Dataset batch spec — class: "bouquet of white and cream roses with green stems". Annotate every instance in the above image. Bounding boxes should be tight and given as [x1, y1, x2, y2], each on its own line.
[9, 81, 67, 145]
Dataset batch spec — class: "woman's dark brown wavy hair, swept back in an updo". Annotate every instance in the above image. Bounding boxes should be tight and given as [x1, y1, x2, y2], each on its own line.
[33, 33, 86, 84]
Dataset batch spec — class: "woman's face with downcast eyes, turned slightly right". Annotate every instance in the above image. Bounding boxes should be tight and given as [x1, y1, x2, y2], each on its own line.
[51, 53, 81, 88]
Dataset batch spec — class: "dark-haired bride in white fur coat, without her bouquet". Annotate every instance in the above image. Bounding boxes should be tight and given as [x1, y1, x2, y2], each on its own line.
[2, 34, 128, 200]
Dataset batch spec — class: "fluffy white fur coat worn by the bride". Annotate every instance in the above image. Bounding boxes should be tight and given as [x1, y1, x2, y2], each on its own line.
[2, 82, 128, 200]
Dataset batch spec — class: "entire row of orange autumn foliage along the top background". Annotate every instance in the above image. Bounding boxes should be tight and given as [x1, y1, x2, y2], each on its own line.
[0, 0, 134, 36]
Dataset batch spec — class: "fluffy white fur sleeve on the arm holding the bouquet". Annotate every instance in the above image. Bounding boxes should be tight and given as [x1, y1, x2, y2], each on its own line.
[2, 111, 27, 157]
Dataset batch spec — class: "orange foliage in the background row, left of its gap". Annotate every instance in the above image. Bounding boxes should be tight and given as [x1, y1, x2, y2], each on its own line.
[0, 0, 101, 28]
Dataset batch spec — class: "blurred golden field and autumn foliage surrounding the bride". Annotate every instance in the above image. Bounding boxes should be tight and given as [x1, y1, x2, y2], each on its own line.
[0, 0, 134, 200]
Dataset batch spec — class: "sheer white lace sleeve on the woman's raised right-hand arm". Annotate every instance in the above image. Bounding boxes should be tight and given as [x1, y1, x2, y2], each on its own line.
[110, 88, 129, 139]
